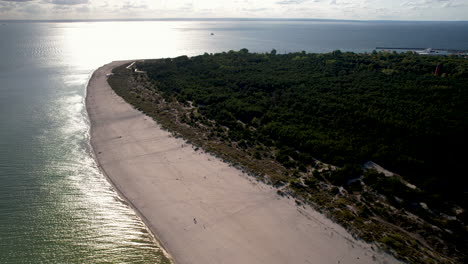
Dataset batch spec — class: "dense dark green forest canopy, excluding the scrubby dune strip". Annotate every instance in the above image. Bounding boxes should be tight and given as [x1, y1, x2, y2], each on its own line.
[138, 50, 468, 209]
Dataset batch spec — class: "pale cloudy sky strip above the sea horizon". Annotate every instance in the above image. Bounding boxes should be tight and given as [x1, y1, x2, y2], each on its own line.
[0, 0, 468, 20]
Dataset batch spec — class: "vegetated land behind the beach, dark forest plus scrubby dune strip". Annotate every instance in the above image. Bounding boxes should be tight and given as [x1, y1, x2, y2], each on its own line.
[94, 49, 468, 263]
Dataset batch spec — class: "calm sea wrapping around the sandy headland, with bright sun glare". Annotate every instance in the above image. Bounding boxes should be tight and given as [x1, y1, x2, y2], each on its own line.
[0, 21, 468, 263]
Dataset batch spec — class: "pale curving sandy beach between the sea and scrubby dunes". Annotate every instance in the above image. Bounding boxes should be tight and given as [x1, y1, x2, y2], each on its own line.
[86, 62, 398, 264]
